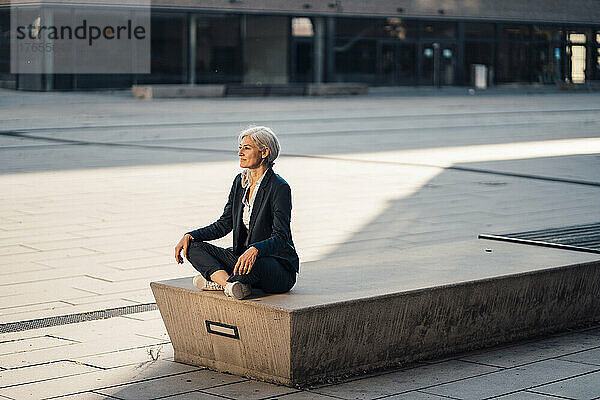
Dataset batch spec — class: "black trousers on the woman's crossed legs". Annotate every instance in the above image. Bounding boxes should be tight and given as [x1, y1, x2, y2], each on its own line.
[188, 242, 296, 293]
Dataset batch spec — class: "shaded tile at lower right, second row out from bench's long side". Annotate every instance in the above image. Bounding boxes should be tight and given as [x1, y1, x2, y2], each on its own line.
[427, 360, 597, 400]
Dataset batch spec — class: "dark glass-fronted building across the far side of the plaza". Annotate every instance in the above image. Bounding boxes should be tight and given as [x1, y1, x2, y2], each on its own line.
[0, 0, 600, 90]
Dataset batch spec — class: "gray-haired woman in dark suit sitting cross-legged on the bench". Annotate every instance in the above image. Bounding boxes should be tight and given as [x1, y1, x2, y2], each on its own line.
[175, 126, 299, 300]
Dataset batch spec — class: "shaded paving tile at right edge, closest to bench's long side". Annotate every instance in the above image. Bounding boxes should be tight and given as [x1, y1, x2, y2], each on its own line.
[461, 331, 600, 367]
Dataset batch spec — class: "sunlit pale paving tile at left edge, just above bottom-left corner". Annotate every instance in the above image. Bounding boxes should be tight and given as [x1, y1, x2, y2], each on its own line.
[0, 361, 98, 388]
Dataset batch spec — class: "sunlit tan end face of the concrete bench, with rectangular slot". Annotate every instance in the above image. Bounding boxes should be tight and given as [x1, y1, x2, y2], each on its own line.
[151, 278, 292, 384]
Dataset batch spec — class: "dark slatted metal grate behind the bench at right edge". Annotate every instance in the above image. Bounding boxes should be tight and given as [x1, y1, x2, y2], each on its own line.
[478, 222, 600, 254]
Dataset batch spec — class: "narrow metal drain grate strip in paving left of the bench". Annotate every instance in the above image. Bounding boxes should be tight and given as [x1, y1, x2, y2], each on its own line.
[0, 303, 158, 333]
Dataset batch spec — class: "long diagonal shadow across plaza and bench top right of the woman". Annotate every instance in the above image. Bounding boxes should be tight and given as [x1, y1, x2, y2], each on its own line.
[299, 155, 600, 304]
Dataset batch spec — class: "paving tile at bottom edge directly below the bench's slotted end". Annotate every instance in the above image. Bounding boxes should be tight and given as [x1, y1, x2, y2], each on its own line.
[96, 363, 246, 400]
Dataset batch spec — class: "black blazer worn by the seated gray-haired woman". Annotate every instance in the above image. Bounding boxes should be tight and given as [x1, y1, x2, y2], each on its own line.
[188, 168, 300, 272]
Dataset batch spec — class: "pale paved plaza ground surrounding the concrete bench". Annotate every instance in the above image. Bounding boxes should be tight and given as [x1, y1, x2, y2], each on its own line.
[0, 89, 600, 400]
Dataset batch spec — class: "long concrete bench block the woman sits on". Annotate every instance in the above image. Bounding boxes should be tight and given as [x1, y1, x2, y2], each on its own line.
[152, 241, 600, 385]
